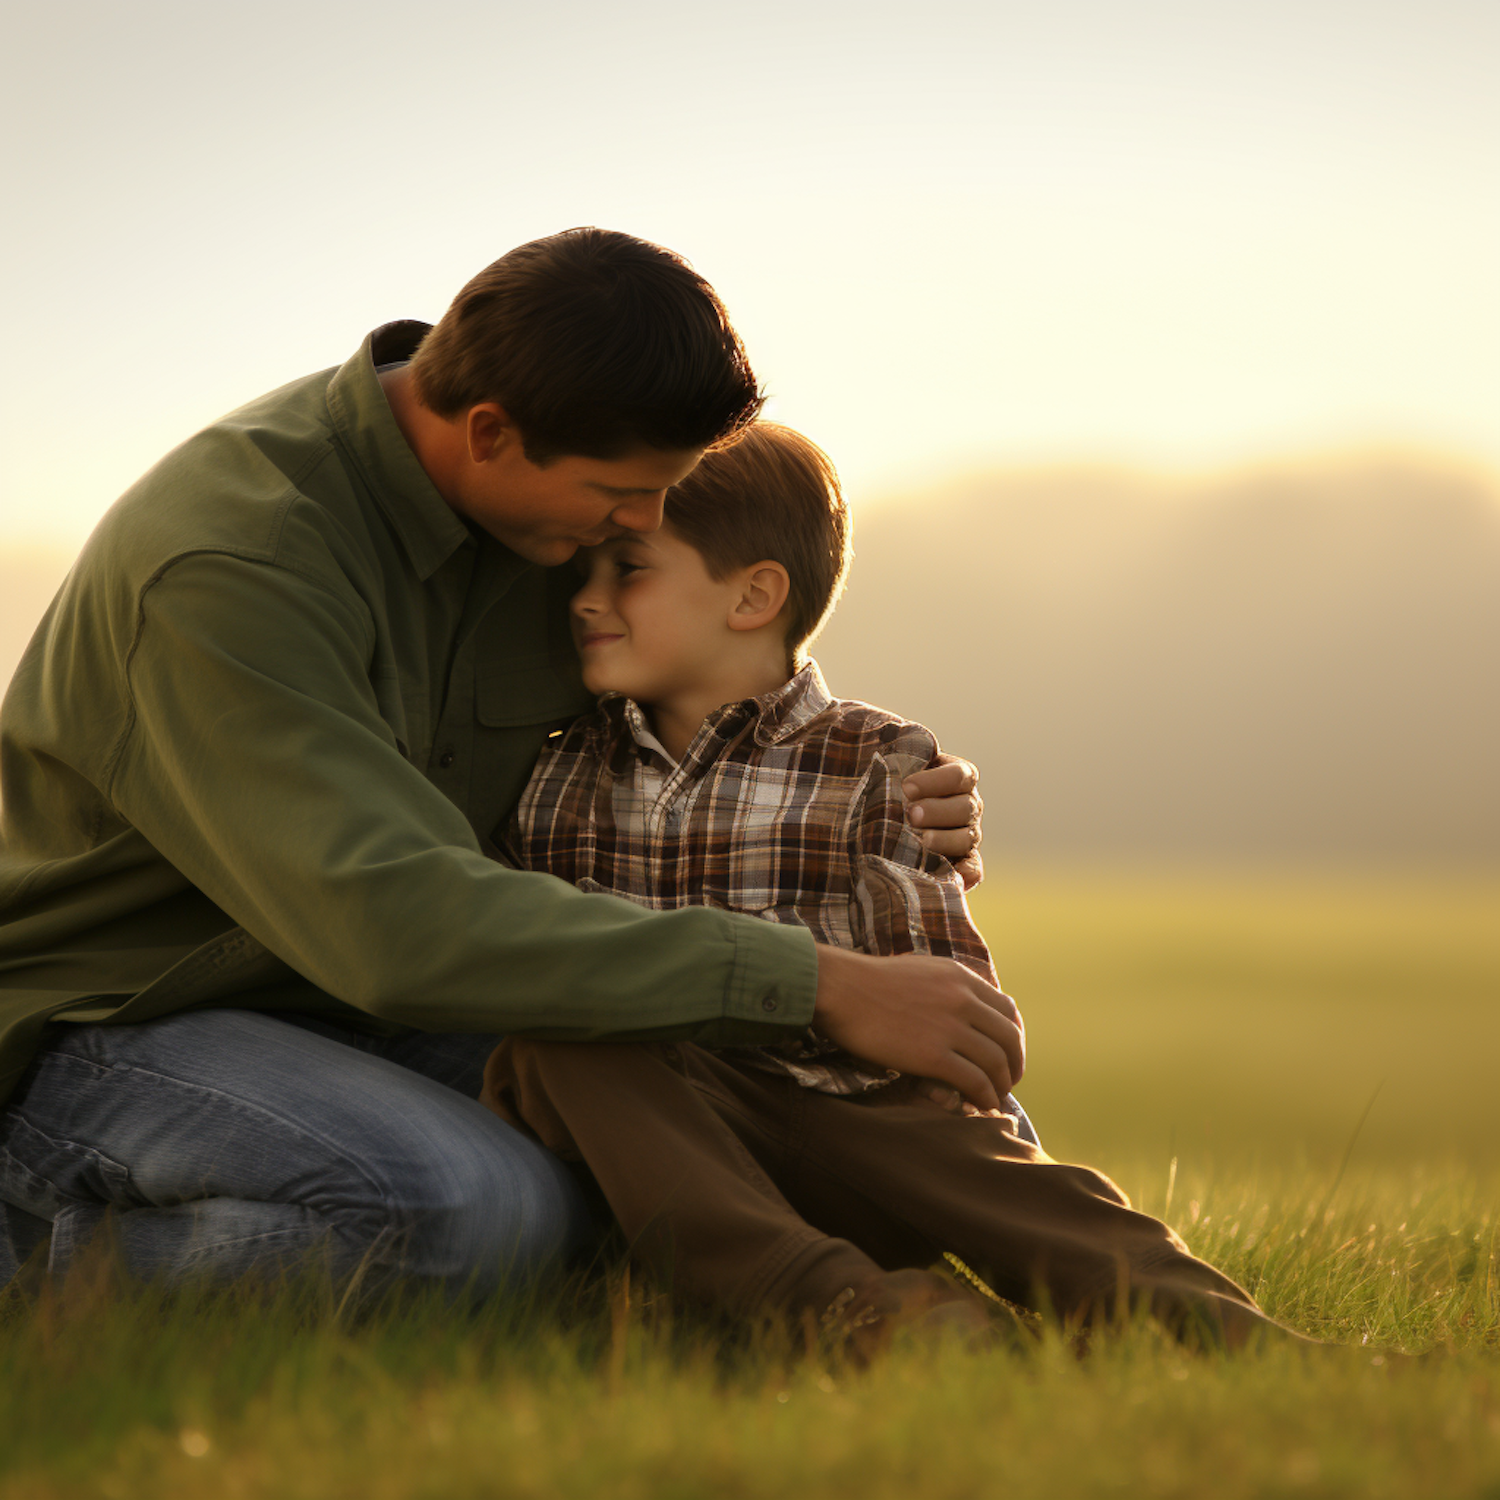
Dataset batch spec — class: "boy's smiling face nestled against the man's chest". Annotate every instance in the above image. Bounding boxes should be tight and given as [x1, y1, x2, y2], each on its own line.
[572, 527, 741, 707]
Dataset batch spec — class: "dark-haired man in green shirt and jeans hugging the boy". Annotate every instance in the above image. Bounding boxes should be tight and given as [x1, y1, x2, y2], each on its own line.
[0, 230, 1017, 1290]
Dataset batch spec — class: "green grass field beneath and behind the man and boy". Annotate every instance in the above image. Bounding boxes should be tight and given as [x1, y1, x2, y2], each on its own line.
[0, 873, 1500, 1500]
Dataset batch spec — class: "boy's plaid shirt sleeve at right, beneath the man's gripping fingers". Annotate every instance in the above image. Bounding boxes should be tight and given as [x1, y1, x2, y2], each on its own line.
[849, 725, 998, 984]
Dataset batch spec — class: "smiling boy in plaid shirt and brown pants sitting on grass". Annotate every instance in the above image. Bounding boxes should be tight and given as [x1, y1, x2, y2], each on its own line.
[483, 425, 1274, 1358]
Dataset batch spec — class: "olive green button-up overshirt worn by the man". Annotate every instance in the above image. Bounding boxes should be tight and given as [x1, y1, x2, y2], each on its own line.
[0, 323, 818, 1101]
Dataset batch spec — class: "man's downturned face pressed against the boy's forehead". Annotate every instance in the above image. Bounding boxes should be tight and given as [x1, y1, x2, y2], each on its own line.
[452, 443, 704, 567]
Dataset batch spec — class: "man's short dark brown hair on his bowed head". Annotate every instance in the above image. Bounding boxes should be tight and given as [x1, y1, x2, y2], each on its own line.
[411, 228, 764, 464]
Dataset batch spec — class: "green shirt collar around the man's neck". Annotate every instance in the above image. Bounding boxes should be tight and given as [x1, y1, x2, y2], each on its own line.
[329, 320, 480, 582]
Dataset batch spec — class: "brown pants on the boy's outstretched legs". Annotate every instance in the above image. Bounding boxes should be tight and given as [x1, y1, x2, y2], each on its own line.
[482, 1038, 1275, 1346]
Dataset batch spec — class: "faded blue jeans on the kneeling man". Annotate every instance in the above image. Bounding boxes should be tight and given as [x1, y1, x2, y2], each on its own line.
[0, 1011, 600, 1295]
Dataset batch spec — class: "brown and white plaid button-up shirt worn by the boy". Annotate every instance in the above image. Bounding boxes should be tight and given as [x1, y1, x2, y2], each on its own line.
[503, 662, 995, 1094]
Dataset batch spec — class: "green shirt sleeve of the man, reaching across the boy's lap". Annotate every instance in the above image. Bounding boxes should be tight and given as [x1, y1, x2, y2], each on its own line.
[108, 554, 818, 1046]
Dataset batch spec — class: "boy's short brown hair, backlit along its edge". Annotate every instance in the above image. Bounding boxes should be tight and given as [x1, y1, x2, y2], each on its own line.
[666, 422, 852, 669]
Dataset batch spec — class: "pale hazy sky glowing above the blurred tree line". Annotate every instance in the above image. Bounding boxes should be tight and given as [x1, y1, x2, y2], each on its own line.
[0, 0, 1500, 543]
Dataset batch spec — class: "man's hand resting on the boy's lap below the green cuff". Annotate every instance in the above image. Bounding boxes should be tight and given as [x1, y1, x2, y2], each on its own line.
[813, 947, 1026, 1110]
